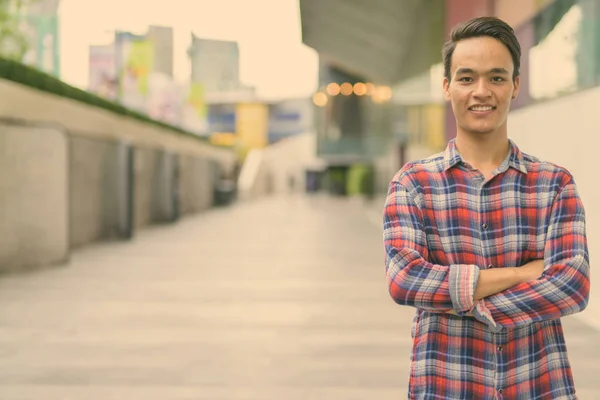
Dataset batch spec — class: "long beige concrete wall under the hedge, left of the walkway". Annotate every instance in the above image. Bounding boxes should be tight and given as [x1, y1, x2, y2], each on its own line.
[0, 80, 235, 271]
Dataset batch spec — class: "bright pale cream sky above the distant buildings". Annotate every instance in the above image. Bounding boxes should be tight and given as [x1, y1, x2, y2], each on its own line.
[59, 0, 318, 97]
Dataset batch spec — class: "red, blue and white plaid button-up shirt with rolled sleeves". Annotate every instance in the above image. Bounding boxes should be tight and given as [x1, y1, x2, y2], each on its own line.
[384, 140, 590, 400]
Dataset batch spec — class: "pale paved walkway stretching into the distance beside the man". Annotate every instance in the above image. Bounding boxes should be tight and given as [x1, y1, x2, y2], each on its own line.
[0, 197, 600, 400]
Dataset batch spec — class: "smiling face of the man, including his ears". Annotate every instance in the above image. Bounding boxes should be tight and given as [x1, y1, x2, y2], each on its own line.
[444, 37, 519, 138]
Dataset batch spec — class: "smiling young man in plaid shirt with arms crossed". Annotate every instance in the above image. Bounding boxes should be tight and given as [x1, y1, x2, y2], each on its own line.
[384, 17, 590, 400]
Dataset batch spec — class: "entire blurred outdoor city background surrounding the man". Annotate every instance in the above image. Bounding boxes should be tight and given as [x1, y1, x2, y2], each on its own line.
[0, 0, 600, 400]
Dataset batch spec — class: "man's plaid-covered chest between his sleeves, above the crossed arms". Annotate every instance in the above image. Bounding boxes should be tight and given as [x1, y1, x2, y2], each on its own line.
[421, 173, 556, 266]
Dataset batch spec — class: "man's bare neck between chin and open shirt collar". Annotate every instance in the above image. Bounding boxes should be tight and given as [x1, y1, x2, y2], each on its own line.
[455, 131, 510, 172]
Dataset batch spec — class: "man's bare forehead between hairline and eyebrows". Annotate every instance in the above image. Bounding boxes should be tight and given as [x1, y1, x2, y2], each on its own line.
[451, 37, 514, 73]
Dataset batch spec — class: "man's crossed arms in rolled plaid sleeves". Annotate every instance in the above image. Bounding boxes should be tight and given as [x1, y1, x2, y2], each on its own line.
[384, 182, 590, 331]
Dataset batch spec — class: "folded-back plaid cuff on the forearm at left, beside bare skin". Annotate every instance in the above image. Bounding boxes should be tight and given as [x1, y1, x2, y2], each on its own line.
[448, 264, 479, 315]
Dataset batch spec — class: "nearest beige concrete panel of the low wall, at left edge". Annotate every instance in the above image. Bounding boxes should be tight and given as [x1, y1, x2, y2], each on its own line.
[0, 124, 69, 270]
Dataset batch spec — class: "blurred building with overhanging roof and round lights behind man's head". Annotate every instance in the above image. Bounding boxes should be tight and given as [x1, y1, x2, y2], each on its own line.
[300, 0, 572, 192]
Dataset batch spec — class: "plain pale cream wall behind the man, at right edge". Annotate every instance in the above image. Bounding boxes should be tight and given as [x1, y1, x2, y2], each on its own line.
[508, 84, 600, 328]
